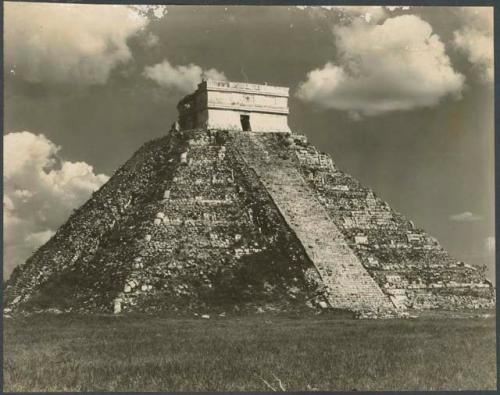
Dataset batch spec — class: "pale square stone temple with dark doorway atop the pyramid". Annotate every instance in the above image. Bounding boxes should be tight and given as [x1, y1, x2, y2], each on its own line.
[177, 80, 290, 133]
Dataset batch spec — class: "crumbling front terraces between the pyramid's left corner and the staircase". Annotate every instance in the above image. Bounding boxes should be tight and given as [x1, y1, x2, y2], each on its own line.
[105, 131, 322, 310]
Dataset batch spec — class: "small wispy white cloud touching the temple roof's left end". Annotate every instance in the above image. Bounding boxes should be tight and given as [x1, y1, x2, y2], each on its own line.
[143, 60, 226, 93]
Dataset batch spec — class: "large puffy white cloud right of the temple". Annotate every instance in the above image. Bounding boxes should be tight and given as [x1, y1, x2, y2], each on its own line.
[297, 15, 464, 116]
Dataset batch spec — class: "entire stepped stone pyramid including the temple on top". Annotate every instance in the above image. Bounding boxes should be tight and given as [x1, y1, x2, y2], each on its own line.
[4, 81, 494, 317]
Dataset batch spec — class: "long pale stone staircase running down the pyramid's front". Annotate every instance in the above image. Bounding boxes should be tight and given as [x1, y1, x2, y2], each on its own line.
[235, 133, 395, 316]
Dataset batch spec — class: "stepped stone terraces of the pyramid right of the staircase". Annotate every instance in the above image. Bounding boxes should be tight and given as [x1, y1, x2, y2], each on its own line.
[289, 136, 494, 309]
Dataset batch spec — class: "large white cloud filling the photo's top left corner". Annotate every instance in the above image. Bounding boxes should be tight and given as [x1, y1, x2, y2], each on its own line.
[4, 2, 148, 84]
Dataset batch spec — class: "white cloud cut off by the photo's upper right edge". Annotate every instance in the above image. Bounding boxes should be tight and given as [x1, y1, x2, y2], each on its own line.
[454, 7, 494, 82]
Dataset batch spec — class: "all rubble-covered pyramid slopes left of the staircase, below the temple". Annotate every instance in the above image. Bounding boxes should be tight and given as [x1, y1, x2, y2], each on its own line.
[4, 130, 322, 311]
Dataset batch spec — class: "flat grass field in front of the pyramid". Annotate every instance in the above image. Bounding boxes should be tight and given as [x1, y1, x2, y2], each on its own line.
[4, 314, 496, 391]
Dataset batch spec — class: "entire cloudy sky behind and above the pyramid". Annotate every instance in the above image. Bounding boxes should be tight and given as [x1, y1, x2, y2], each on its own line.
[4, 2, 495, 282]
